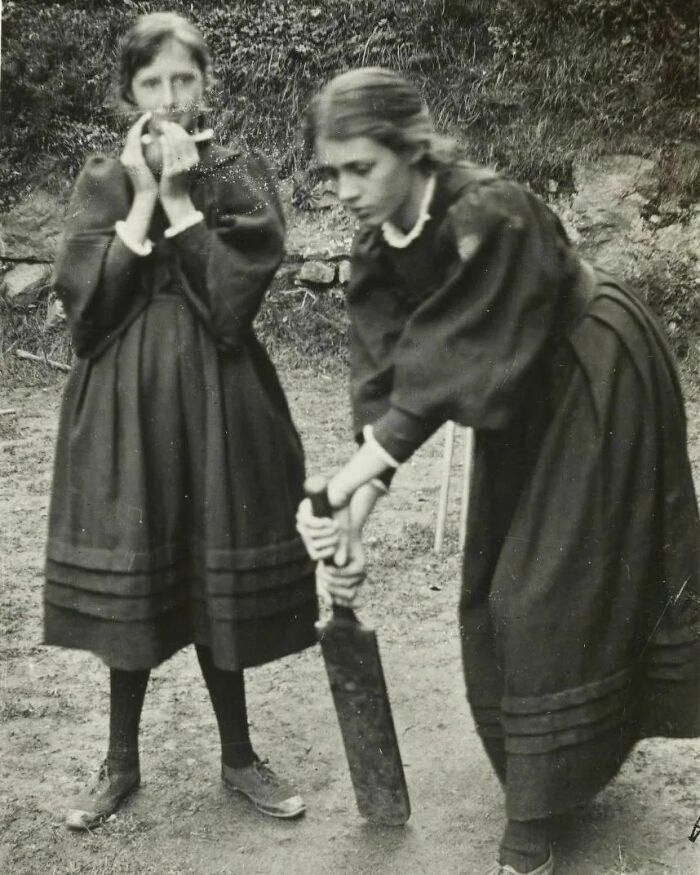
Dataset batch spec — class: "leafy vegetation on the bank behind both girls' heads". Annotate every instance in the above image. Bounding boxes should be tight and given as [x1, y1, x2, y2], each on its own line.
[0, 0, 698, 202]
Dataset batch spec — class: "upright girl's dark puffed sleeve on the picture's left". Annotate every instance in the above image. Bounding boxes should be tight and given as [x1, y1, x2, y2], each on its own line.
[53, 157, 152, 358]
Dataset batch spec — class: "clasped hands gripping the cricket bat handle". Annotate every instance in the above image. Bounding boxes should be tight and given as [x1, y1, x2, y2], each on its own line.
[297, 498, 367, 607]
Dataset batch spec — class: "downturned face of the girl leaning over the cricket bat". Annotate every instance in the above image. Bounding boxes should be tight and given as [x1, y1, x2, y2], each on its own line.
[316, 135, 418, 228]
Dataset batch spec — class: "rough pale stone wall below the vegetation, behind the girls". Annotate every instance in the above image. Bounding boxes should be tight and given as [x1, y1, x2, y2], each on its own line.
[0, 155, 700, 348]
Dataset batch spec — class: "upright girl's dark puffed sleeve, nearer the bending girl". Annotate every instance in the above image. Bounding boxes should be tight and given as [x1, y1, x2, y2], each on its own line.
[168, 154, 285, 348]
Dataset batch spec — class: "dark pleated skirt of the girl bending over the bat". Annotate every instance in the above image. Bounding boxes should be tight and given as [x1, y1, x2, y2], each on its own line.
[460, 283, 700, 820]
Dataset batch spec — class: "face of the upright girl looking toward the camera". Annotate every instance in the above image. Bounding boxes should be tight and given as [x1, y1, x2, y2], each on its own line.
[131, 39, 206, 131]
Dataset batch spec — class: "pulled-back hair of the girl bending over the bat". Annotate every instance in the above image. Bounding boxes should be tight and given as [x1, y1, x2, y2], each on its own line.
[304, 67, 458, 166]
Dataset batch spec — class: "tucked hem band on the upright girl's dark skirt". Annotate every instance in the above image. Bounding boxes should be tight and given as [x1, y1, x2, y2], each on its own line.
[45, 538, 317, 670]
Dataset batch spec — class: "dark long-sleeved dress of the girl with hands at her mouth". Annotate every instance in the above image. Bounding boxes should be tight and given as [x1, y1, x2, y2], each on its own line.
[45, 145, 317, 670]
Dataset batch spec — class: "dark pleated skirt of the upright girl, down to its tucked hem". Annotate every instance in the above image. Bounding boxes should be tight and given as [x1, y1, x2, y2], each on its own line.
[44, 295, 317, 670]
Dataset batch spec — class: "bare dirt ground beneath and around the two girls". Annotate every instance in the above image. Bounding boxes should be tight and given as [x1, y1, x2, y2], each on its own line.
[0, 370, 700, 875]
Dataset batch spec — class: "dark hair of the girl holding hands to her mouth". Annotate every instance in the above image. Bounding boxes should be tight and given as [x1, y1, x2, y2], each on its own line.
[116, 12, 211, 105]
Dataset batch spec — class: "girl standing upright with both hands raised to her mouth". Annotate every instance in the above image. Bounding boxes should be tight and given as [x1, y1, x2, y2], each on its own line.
[45, 13, 317, 829]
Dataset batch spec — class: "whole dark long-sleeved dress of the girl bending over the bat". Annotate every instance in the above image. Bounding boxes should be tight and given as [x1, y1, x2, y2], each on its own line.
[347, 164, 700, 820]
